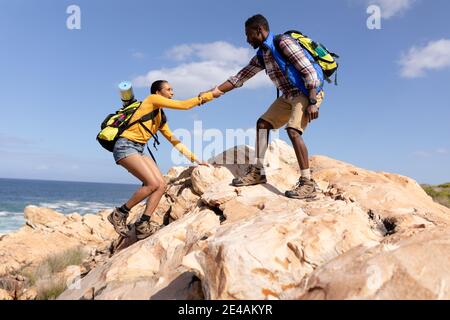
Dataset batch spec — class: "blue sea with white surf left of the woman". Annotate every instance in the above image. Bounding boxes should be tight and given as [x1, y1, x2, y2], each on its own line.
[0, 178, 138, 235]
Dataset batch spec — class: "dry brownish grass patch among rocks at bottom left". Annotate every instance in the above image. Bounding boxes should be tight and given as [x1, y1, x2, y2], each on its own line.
[20, 247, 88, 300]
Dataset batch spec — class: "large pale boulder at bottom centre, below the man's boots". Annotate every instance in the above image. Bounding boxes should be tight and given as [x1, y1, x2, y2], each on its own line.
[183, 199, 381, 300]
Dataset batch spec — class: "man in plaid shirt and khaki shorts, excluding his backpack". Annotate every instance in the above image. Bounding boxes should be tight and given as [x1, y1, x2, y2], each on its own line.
[214, 14, 324, 199]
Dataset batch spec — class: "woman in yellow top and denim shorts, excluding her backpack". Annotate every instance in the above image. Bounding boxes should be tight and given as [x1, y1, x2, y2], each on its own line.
[108, 80, 222, 240]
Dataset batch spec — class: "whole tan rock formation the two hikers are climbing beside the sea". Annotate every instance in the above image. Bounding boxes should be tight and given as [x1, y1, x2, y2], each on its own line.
[0, 140, 450, 299]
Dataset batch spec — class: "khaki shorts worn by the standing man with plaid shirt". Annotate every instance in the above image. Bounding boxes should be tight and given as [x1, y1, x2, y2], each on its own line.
[260, 91, 325, 132]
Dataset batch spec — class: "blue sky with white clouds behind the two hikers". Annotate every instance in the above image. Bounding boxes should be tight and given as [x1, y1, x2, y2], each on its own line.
[0, 0, 450, 183]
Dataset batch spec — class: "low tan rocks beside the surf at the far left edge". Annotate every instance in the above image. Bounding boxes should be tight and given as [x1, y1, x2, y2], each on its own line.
[0, 206, 123, 276]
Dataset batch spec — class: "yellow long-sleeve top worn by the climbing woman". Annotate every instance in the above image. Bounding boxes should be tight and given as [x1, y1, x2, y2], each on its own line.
[121, 92, 214, 162]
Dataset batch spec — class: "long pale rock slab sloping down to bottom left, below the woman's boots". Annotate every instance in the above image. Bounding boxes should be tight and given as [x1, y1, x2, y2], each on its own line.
[59, 210, 219, 300]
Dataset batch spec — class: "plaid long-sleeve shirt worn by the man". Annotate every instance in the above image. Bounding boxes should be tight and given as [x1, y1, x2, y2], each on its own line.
[228, 36, 320, 99]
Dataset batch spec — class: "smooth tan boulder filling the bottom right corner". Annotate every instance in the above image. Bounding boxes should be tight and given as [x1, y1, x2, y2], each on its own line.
[296, 228, 450, 300]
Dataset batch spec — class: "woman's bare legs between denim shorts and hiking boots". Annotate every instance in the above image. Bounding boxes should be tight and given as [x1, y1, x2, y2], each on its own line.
[118, 154, 165, 209]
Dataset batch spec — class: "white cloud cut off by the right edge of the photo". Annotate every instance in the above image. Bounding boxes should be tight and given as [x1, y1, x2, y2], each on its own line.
[399, 39, 450, 78]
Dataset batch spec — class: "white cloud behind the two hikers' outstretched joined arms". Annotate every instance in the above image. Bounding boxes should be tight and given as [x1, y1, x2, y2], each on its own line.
[133, 41, 271, 98]
